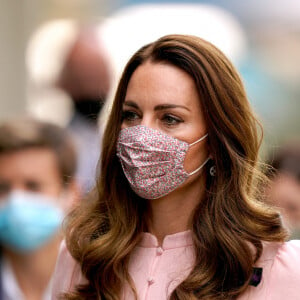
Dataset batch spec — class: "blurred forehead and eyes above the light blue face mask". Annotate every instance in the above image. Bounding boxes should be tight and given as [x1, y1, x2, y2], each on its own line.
[0, 148, 63, 198]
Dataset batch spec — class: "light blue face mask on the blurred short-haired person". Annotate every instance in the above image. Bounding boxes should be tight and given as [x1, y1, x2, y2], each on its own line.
[0, 191, 64, 252]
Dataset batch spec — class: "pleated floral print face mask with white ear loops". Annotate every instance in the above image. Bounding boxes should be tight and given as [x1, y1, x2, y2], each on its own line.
[117, 125, 210, 199]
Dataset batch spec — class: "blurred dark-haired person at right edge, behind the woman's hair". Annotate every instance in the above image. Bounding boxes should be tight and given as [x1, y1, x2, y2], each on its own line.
[266, 140, 300, 238]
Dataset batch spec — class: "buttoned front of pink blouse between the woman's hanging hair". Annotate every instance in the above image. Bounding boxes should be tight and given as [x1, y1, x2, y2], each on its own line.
[123, 231, 195, 300]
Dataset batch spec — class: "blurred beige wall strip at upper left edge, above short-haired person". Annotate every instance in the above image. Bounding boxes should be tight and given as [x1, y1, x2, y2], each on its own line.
[0, 0, 25, 120]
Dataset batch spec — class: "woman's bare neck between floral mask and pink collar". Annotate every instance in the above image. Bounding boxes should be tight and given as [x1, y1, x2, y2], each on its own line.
[148, 180, 204, 245]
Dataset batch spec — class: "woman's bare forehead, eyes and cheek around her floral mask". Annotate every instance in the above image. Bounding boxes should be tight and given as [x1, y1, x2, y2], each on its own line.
[122, 61, 209, 172]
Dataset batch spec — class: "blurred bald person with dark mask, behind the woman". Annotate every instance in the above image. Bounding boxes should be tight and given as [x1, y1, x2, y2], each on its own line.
[56, 28, 110, 192]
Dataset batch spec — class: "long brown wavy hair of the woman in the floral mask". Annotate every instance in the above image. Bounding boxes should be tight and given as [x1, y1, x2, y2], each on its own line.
[63, 35, 286, 300]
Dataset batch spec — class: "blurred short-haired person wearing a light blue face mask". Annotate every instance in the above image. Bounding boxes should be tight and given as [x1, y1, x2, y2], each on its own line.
[0, 118, 79, 300]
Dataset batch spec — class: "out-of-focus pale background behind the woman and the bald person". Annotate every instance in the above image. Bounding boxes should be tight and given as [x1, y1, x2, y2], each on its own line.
[0, 0, 300, 159]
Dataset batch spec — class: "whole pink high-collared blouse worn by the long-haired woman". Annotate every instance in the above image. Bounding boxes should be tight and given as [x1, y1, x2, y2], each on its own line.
[52, 231, 300, 300]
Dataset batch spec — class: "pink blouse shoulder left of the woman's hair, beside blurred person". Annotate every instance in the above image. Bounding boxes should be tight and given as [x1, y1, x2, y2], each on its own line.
[52, 241, 85, 300]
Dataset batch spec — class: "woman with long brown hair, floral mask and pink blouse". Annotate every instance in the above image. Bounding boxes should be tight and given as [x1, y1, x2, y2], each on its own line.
[53, 35, 300, 300]
